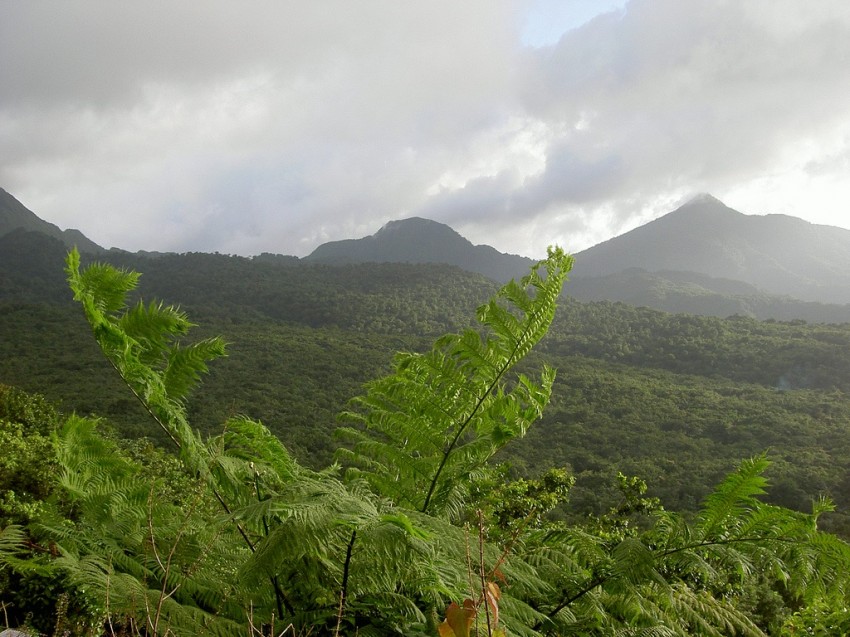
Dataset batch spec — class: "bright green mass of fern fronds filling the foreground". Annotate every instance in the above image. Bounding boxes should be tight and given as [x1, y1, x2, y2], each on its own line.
[61, 249, 850, 637]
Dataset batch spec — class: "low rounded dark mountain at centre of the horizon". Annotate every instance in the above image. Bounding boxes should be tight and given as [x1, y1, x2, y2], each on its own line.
[304, 217, 534, 282]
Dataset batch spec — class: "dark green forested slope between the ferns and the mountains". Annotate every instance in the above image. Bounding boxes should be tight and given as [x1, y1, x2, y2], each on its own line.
[0, 235, 850, 529]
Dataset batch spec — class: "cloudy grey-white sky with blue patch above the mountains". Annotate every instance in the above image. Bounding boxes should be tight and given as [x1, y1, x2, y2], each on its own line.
[0, 0, 850, 258]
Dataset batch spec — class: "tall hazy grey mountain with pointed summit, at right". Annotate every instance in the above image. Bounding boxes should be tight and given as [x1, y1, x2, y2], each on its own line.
[573, 195, 850, 304]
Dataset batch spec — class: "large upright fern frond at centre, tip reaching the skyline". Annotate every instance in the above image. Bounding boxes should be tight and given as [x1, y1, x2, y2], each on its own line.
[339, 249, 572, 513]
